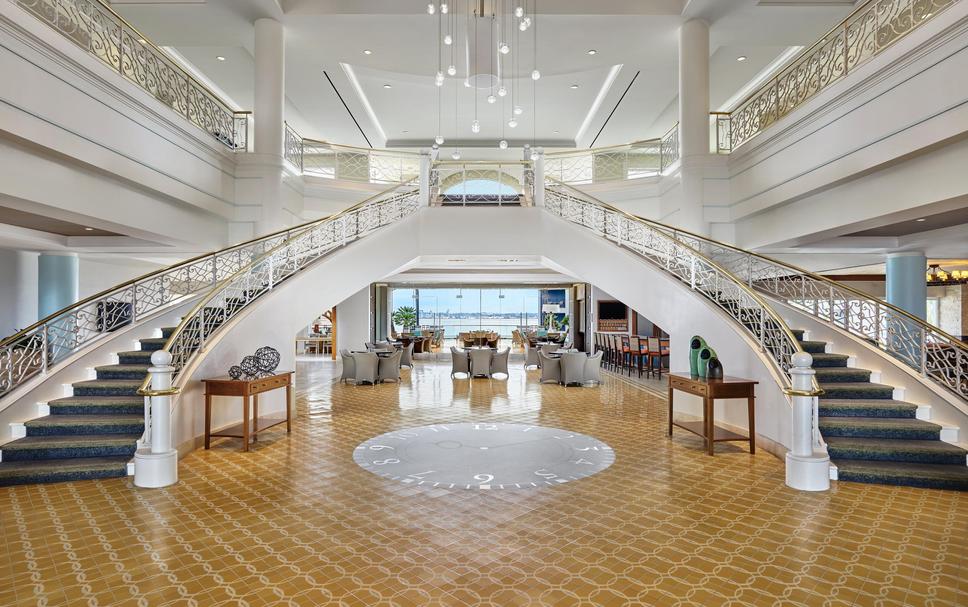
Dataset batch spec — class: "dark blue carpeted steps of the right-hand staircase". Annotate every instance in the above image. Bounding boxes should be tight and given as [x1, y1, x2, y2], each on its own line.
[793, 330, 968, 491]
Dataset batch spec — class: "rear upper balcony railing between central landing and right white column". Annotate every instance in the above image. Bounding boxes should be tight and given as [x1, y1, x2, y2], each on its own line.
[545, 123, 679, 185]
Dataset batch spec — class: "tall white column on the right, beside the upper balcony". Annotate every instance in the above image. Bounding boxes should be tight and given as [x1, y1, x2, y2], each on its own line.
[673, 19, 709, 234]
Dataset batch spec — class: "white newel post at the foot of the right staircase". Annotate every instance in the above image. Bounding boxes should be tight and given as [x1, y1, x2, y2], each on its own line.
[786, 352, 830, 491]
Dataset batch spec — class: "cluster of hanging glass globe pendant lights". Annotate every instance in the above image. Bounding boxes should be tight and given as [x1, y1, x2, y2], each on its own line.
[427, 0, 541, 152]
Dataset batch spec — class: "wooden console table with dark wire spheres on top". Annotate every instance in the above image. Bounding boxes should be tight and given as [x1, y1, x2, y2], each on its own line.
[202, 371, 293, 451]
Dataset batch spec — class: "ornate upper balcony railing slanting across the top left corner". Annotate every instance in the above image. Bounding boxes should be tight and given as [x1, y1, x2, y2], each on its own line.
[9, 0, 249, 151]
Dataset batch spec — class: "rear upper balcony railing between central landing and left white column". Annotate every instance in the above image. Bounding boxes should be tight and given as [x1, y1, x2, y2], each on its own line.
[285, 124, 420, 185]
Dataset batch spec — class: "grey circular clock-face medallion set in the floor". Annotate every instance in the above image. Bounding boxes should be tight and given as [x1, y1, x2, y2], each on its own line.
[353, 423, 615, 489]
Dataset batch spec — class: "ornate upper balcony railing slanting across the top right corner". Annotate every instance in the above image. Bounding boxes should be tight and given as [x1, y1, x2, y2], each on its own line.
[713, 0, 961, 153]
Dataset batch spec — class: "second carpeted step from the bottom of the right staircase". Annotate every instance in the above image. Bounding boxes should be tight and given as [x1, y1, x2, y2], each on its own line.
[824, 436, 968, 466]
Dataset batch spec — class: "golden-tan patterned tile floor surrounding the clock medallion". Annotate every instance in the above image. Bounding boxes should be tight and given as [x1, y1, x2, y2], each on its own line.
[0, 361, 968, 607]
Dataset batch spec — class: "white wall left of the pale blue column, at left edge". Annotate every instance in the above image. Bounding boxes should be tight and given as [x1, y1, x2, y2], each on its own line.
[0, 249, 38, 336]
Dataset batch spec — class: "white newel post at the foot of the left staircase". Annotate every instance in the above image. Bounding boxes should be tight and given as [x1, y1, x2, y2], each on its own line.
[134, 350, 178, 488]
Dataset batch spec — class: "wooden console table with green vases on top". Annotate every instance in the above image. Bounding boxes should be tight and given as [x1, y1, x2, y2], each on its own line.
[669, 373, 759, 455]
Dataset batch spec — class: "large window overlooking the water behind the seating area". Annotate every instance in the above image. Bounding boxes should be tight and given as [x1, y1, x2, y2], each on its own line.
[390, 287, 561, 339]
